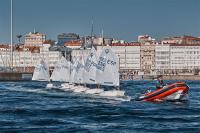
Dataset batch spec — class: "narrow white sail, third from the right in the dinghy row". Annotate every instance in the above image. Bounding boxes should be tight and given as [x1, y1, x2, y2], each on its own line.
[74, 56, 84, 84]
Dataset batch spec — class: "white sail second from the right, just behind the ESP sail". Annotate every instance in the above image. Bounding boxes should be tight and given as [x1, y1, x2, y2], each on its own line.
[83, 47, 97, 84]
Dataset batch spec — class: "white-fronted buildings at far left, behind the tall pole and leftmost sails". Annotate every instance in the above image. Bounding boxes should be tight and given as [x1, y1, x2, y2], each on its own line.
[0, 47, 62, 67]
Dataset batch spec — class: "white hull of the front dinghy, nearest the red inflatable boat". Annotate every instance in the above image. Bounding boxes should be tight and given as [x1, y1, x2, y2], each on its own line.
[99, 90, 125, 97]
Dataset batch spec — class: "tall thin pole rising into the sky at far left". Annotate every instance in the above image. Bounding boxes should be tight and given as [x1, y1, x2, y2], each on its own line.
[10, 0, 13, 71]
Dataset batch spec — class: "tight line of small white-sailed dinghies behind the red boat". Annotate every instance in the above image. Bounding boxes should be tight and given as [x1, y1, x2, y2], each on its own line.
[32, 46, 125, 97]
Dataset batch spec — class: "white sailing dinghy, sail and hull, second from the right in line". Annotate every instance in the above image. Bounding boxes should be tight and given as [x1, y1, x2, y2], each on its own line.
[83, 47, 104, 94]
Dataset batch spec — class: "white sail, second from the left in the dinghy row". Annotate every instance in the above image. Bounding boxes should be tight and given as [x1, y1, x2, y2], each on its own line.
[50, 57, 70, 82]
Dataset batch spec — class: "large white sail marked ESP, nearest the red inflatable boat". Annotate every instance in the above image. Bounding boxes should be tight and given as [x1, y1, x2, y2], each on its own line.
[96, 46, 119, 86]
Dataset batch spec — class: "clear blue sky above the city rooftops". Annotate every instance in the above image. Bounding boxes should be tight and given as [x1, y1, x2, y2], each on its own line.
[0, 0, 200, 43]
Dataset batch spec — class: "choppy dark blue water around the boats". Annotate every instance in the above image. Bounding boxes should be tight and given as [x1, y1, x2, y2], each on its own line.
[0, 81, 200, 133]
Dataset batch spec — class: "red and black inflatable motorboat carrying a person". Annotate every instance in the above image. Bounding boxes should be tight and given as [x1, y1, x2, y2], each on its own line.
[136, 82, 189, 102]
